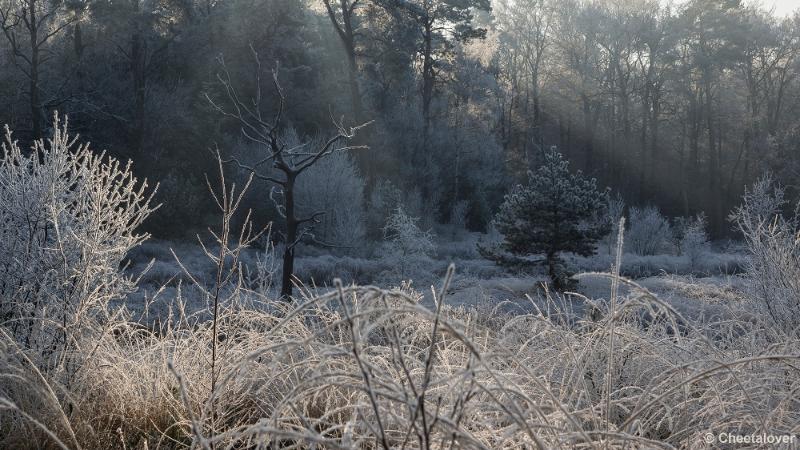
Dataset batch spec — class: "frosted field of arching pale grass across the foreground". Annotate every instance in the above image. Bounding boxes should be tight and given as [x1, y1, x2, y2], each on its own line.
[0, 227, 800, 448]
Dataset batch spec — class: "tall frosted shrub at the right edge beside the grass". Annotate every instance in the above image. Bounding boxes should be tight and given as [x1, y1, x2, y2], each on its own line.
[730, 176, 800, 334]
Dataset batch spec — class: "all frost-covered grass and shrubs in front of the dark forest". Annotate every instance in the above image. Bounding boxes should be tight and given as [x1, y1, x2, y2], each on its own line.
[0, 122, 800, 448]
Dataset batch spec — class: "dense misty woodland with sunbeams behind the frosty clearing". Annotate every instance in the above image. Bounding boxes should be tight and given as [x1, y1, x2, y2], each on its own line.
[0, 0, 800, 241]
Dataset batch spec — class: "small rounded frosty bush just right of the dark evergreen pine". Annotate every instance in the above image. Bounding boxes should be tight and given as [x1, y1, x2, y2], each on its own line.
[625, 206, 672, 256]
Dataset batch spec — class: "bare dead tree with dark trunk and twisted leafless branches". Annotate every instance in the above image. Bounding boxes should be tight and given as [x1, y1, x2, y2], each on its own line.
[206, 48, 369, 299]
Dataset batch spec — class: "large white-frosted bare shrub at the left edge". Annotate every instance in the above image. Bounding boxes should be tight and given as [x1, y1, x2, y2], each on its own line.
[0, 117, 154, 355]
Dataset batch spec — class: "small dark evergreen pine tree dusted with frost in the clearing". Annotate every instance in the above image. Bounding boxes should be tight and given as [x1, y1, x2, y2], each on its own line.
[494, 147, 608, 289]
